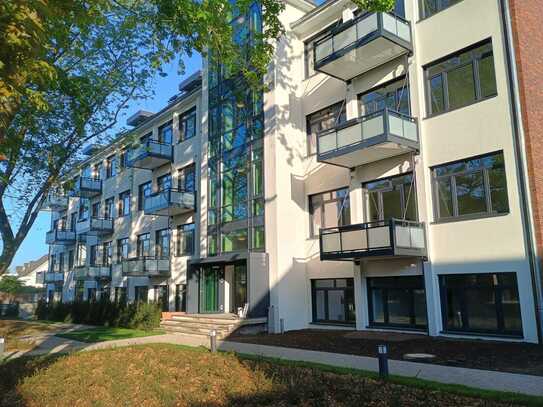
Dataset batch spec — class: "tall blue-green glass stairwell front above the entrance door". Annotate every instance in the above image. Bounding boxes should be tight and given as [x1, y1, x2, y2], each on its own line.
[208, 3, 264, 256]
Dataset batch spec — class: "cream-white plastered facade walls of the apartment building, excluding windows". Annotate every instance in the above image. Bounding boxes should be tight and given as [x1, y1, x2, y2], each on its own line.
[47, 0, 538, 342]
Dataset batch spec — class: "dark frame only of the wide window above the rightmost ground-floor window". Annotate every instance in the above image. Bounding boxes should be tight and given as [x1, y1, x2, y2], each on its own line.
[430, 150, 511, 223]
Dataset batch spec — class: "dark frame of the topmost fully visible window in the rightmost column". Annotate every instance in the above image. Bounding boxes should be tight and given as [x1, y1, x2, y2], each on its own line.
[423, 38, 498, 118]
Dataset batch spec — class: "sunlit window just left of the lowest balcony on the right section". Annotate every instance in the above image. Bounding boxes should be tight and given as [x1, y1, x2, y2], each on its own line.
[309, 188, 351, 237]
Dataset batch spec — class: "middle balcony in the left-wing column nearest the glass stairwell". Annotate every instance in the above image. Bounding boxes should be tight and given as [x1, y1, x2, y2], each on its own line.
[143, 189, 196, 216]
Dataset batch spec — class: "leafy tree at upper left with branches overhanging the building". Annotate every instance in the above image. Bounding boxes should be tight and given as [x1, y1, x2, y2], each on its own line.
[0, 0, 393, 275]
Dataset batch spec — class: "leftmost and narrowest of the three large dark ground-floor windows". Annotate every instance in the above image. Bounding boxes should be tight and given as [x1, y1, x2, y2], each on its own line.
[311, 278, 356, 324]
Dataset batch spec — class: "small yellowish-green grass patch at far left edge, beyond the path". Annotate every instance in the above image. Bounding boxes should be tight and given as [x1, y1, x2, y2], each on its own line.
[0, 319, 59, 352]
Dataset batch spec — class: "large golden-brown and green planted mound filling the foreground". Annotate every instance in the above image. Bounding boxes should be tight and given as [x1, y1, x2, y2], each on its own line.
[0, 345, 543, 407]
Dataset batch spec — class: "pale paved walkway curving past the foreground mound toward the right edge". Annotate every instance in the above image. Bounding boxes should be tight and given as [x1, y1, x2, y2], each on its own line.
[4, 334, 543, 396]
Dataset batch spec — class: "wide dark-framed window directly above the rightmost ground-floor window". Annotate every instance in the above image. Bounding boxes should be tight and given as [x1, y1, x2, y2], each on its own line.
[432, 152, 509, 220]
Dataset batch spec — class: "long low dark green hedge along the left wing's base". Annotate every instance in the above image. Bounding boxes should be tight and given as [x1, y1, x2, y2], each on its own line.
[35, 298, 162, 330]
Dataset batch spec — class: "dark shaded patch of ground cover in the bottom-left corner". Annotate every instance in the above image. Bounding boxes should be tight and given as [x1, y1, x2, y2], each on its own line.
[0, 355, 64, 407]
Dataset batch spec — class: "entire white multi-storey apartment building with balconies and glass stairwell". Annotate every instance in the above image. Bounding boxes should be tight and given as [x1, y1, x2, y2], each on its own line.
[42, 0, 543, 342]
